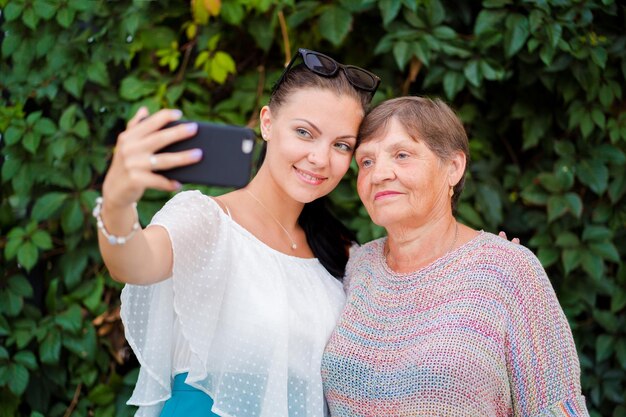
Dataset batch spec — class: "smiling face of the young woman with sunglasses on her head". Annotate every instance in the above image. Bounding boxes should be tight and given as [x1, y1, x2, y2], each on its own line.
[261, 89, 363, 203]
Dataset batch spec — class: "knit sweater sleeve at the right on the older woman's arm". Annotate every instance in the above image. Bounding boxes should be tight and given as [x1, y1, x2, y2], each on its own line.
[505, 247, 588, 416]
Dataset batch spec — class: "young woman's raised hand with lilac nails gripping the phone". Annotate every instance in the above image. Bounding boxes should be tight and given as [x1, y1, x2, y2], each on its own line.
[102, 107, 202, 208]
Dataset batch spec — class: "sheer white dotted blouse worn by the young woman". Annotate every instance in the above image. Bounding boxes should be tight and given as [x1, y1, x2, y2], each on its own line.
[121, 191, 345, 417]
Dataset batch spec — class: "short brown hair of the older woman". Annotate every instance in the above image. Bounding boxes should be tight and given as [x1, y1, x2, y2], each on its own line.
[357, 96, 470, 210]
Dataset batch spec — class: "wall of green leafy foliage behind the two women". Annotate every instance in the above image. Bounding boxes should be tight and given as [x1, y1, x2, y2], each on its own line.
[0, 0, 626, 417]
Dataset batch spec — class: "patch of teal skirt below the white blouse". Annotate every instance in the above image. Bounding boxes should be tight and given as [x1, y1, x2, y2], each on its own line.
[161, 373, 219, 417]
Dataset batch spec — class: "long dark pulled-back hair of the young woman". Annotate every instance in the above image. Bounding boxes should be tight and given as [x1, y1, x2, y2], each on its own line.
[257, 64, 371, 279]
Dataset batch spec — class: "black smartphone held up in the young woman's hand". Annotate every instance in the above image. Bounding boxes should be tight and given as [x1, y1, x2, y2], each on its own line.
[157, 120, 256, 188]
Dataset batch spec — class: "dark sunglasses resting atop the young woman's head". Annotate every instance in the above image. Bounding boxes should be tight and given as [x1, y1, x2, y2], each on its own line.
[272, 48, 380, 96]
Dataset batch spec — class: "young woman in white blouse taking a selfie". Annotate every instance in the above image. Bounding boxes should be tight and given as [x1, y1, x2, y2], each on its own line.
[95, 49, 379, 417]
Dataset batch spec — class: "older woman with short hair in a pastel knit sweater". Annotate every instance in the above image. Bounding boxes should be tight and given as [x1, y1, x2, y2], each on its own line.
[322, 97, 588, 417]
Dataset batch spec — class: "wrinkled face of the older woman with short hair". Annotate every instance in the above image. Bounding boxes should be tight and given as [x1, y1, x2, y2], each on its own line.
[355, 119, 453, 228]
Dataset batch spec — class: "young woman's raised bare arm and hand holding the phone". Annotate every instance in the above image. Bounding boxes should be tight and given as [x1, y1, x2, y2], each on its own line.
[98, 108, 199, 285]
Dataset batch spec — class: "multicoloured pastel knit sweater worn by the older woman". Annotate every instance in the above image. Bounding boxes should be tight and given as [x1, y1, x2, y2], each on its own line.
[322, 232, 588, 417]
